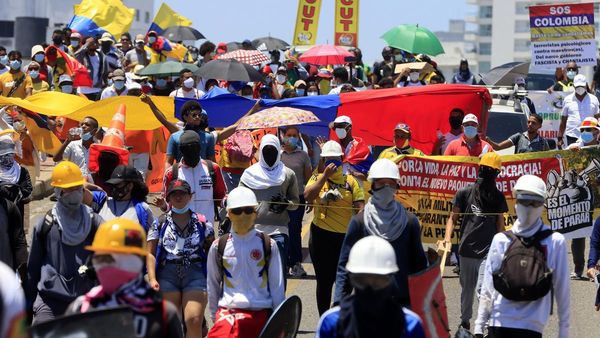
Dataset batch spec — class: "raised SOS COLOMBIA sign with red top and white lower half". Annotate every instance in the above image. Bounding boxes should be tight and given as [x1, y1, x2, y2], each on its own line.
[529, 3, 596, 69]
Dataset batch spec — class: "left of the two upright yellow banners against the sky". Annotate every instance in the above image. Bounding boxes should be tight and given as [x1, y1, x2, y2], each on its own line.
[292, 0, 321, 46]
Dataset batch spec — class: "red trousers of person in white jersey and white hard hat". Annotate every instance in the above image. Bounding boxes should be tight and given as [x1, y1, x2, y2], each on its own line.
[207, 308, 271, 338]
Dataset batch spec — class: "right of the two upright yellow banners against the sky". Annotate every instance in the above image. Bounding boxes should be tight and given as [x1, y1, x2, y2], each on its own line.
[333, 0, 358, 47]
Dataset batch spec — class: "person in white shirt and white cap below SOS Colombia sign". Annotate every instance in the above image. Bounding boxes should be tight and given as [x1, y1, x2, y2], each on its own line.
[557, 74, 600, 149]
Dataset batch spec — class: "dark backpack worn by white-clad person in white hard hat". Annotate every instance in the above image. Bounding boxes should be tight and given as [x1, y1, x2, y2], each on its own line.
[492, 229, 552, 304]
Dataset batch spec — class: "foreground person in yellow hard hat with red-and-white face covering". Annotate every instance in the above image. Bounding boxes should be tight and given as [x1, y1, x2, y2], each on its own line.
[67, 218, 184, 338]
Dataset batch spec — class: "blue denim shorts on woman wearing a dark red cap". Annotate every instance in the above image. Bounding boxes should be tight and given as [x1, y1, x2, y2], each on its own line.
[157, 262, 206, 292]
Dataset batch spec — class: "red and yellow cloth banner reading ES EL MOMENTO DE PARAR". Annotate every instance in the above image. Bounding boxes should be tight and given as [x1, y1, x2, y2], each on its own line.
[396, 147, 600, 243]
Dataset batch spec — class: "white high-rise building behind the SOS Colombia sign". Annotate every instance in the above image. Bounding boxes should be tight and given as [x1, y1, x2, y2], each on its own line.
[465, 0, 599, 73]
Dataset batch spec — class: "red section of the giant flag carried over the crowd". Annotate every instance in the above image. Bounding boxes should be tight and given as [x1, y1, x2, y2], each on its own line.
[332, 84, 492, 154]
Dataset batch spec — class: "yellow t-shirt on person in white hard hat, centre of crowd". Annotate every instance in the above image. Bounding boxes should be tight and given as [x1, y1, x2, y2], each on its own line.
[306, 173, 365, 233]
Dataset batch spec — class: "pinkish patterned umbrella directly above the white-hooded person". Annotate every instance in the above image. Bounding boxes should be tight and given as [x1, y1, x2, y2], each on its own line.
[238, 107, 320, 129]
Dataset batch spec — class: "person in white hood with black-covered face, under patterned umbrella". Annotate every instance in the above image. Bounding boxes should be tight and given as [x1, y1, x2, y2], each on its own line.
[240, 134, 300, 280]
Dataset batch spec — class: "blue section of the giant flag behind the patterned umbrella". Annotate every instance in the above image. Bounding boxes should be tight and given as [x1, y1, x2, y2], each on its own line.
[175, 88, 340, 136]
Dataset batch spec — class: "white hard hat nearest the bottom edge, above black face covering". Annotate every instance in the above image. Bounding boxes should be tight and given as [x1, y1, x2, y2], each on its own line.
[346, 236, 398, 275]
